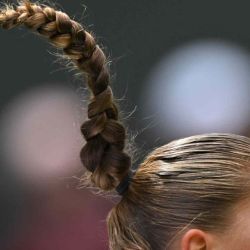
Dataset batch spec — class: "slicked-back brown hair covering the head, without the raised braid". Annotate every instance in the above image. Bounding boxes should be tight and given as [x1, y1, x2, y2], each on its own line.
[109, 134, 250, 250]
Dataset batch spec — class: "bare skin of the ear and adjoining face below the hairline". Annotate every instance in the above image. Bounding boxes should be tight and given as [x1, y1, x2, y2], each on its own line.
[173, 198, 250, 250]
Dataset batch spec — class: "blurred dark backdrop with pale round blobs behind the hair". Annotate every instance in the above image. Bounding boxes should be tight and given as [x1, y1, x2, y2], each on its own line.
[0, 0, 250, 250]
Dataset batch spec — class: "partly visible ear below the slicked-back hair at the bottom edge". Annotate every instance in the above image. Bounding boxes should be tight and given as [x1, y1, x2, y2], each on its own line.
[181, 229, 211, 250]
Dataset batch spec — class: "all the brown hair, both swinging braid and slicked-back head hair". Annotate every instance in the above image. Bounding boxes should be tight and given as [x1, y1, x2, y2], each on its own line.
[0, 1, 250, 250]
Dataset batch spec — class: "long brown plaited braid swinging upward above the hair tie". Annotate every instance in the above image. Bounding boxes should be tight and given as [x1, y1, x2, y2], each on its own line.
[0, 1, 131, 190]
